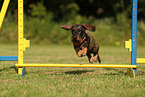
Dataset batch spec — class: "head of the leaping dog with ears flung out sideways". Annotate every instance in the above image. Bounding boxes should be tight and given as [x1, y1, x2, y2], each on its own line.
[60, 25, 96, 42]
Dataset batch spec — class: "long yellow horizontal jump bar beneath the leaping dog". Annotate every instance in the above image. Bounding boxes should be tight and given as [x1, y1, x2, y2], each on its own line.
[15, 63, 137, 68]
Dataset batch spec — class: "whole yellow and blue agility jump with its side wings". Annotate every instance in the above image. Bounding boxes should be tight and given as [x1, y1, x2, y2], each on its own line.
[0, 0, 145, 77]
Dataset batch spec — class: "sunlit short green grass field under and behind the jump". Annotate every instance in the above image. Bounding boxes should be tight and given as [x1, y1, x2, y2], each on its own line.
[0, 44, 145, 97]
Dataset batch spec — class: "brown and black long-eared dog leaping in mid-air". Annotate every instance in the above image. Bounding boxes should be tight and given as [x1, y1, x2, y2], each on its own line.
[60, 25, 101, 63]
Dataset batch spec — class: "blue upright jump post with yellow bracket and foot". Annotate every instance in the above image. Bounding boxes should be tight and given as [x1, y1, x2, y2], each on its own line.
[125, 0, 138, 77]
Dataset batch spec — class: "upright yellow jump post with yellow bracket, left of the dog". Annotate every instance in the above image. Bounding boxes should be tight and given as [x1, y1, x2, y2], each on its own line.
[18, 0, 30, 76]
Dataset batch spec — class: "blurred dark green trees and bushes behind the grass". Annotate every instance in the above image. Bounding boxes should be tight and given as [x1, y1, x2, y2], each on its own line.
[0, 0, 145, 46]
